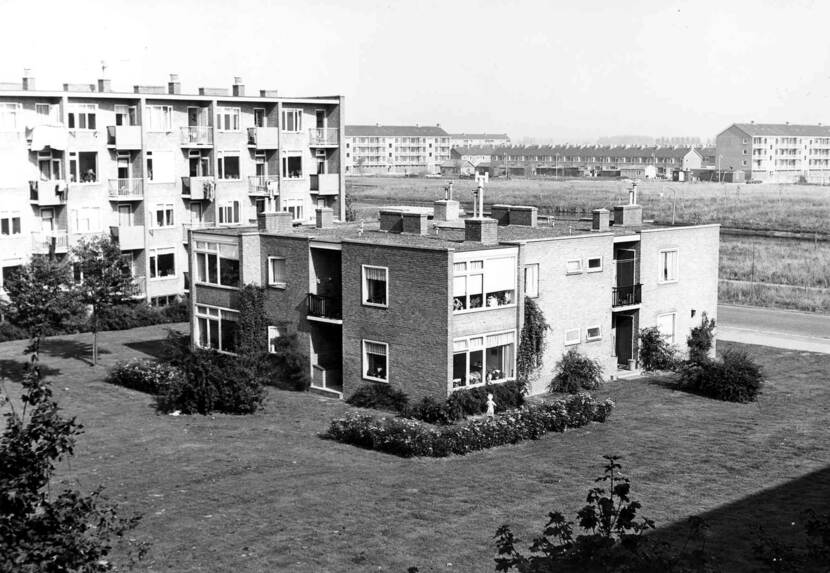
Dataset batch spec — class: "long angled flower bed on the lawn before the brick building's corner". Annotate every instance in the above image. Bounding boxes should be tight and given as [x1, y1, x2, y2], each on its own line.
[325, 394, 614, 458]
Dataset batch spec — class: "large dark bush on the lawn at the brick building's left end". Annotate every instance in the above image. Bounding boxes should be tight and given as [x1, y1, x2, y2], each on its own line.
[156, 350, 265, 414]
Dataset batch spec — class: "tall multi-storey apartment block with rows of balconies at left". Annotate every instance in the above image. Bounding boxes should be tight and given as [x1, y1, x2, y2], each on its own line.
[0, 74, 344, 304]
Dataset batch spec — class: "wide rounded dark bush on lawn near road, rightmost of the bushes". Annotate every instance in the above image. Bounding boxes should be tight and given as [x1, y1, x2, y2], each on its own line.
[680, 349, 764, 402]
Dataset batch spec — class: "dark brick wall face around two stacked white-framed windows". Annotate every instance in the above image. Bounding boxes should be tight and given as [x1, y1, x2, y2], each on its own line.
[342, 243, 451, 400]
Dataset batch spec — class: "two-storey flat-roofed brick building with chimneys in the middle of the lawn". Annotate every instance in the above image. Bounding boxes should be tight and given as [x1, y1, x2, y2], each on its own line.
[190, 194, 719, 398]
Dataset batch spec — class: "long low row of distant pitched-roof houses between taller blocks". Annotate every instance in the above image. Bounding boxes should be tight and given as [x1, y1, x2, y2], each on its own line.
[492, 145, 703, 180]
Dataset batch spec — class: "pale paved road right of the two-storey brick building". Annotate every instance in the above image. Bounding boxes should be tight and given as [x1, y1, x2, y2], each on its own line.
[718, 304, 830, 354]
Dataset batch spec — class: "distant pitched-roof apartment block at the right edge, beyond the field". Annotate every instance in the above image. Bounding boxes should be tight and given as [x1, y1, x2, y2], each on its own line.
[715, 123, 830, 183]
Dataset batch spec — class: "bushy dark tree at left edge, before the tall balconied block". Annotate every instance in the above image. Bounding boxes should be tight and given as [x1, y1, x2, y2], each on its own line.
[2, 255, 78, 354]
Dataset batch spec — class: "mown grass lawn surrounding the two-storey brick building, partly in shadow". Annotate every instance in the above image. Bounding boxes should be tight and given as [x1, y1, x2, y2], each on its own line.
[0, 327, 830, 572]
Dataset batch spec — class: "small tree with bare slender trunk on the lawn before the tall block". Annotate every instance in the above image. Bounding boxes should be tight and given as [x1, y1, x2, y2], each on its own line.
[72, 237, 132, 364]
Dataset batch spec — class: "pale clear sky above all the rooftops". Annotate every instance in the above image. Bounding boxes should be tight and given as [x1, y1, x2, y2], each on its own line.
[0, 0, 830, 142]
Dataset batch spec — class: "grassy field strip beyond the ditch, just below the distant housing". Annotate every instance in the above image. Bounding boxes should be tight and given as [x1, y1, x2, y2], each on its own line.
[346, 177, 830, 233]
